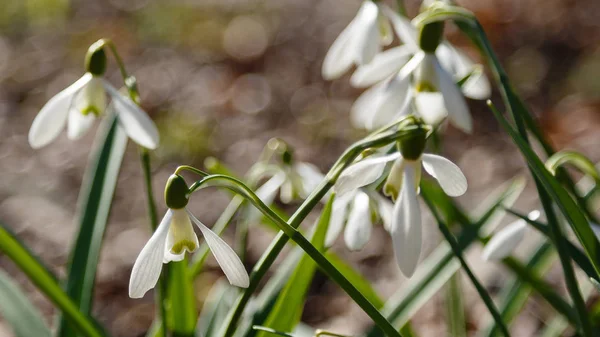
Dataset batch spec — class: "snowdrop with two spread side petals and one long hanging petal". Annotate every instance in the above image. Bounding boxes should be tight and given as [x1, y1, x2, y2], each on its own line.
[334, 118, 467, 277]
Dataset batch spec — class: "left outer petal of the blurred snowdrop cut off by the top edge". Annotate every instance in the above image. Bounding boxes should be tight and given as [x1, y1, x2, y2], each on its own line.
[321, 15, 356, 81]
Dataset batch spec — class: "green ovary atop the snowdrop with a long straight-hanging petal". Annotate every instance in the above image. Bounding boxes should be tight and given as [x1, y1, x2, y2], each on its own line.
[397, 116, 429, 160]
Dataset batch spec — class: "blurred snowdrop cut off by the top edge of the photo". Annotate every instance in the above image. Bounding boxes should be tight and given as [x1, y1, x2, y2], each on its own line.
[321, 0, 393, 80]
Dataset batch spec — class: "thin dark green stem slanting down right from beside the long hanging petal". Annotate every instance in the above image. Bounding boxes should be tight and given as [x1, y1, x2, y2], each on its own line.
[423, 196, 510, 337]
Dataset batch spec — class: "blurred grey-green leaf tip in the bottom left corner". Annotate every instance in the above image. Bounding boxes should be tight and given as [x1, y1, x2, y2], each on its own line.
[0, 270, 52, 337]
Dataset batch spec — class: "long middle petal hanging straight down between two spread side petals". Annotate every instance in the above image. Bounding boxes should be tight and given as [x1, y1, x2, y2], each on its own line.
[390, 161, 422, 277]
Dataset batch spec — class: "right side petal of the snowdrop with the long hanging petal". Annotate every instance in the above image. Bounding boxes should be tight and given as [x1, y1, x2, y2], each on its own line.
[421, 153, 467, 197]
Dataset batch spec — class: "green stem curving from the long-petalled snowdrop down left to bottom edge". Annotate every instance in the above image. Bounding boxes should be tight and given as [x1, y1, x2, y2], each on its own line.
[216, 130, 398, 337]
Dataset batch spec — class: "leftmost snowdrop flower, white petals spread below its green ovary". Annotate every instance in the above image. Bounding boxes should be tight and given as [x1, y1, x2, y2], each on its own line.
[29, 44, 159, 149]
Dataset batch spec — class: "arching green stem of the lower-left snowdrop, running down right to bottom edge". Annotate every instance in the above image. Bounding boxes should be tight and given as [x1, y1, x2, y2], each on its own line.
[191, 174, 401, 337]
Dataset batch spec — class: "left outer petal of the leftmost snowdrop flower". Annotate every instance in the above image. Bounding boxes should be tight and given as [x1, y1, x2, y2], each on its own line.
[28, 73, 92, 149]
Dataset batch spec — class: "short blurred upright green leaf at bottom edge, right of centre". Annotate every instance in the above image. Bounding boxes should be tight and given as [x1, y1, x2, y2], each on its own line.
[446, 273, 467, 337]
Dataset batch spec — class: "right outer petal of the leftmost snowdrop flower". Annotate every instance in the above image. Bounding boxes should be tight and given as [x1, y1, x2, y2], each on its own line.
[104, 82, 159, 150]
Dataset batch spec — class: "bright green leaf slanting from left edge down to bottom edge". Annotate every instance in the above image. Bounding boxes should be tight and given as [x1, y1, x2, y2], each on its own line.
[0, 225, 106, 337]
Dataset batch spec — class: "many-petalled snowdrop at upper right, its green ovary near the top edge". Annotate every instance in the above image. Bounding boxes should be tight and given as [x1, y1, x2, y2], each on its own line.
[350, 8, 491, 133]
